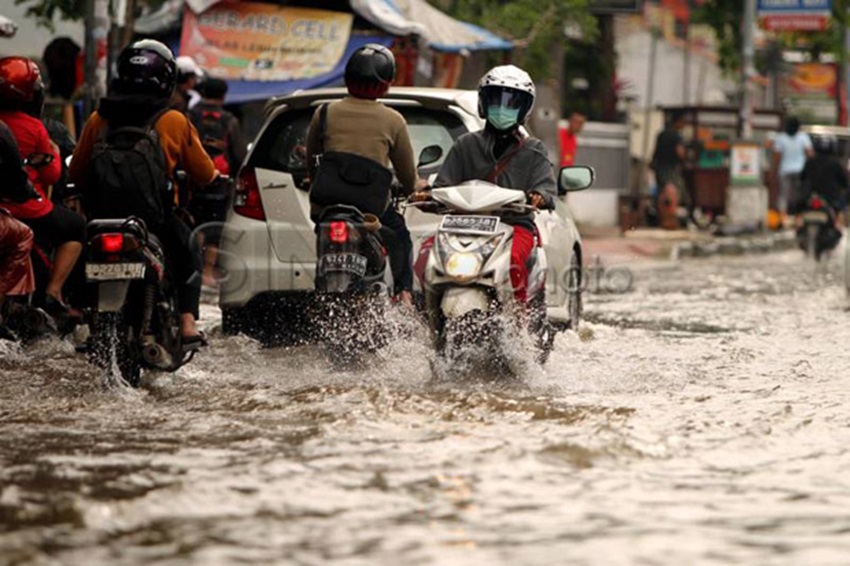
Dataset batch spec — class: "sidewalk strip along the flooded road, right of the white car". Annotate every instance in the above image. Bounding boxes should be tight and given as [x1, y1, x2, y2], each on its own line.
[579, 226, 797, 265]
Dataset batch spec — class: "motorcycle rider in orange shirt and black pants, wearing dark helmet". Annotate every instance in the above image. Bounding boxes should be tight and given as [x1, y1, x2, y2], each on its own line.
[69, 39, 219, 344]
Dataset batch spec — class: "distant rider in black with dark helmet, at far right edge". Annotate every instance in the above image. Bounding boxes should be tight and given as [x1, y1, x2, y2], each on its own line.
[800, 135, 850, 225]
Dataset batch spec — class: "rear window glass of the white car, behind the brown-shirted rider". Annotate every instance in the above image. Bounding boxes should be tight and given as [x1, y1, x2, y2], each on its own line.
[251, 102, 467, 181]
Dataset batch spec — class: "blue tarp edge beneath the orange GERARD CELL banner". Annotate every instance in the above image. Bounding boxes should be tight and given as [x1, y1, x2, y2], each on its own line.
[219, 35, 393, 104]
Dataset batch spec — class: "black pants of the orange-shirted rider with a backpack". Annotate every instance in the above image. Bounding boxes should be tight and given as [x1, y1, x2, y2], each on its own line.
[154, 213, 204, 319]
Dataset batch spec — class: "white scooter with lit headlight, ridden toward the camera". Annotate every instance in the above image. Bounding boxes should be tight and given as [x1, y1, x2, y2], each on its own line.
[410, 168, 593, 363]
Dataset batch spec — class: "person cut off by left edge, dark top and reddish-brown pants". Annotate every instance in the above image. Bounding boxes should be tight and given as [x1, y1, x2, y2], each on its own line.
[0, 122, 35, 340]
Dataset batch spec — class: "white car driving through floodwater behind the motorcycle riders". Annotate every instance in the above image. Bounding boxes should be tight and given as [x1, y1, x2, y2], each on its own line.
[219, 87, 582, 342]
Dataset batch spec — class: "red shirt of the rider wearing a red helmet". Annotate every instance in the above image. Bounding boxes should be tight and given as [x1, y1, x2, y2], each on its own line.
[0, 111, 62, 219]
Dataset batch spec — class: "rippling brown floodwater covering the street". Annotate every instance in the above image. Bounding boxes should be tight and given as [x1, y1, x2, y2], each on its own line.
[0, 252, 850, 566]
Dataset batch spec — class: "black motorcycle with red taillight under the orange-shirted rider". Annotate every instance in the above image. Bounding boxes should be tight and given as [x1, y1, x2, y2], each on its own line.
[85, 216, 199, 387]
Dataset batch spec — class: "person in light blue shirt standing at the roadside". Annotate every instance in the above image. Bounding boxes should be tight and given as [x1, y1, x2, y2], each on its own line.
[772, 116, 814, 214]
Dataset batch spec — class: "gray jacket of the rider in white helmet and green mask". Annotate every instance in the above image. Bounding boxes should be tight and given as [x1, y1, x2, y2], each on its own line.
[434, 129, 558, 208]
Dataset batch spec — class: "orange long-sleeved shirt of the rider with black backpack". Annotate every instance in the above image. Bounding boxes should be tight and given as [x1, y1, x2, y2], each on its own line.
[68, 110, 218, 204]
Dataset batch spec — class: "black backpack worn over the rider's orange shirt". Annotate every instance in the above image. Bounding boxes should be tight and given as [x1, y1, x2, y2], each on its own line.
[85, 109, 174, 229]
